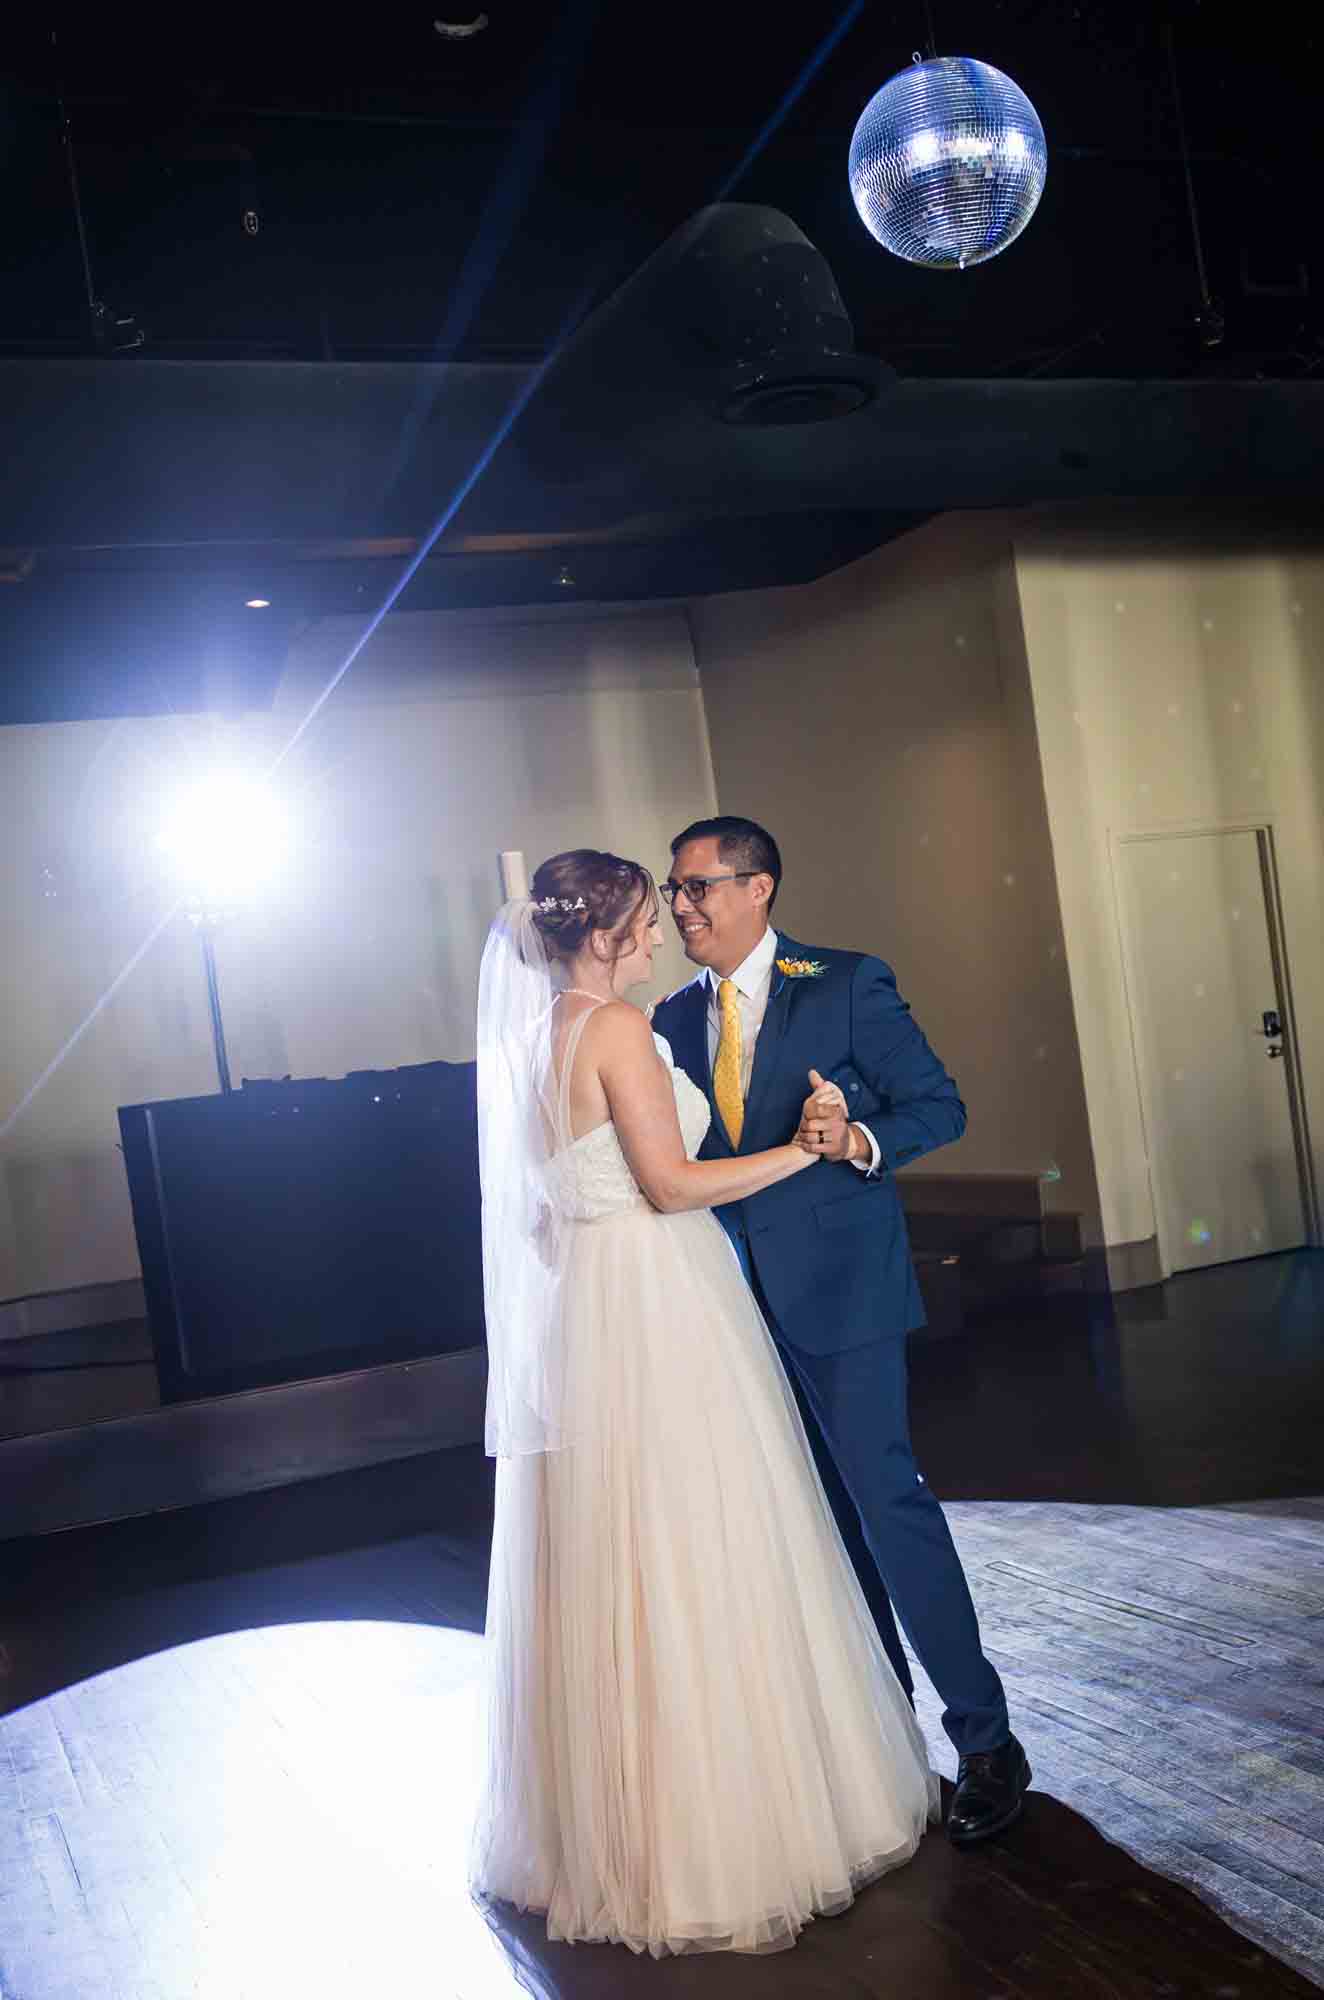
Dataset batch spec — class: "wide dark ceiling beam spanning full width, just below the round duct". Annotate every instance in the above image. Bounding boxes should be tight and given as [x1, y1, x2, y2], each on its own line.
[0, 358, 1324, 548]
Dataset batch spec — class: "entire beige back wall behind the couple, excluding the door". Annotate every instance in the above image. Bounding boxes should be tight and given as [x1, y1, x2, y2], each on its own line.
[18, 506, 1324, 1300]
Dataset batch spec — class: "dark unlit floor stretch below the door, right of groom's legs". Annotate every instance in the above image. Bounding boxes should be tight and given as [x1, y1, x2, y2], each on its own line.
[910, 1250, 1324, 1506]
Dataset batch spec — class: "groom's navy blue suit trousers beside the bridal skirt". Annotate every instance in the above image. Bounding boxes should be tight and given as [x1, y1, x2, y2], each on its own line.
[728, 1232, 1010, 1756]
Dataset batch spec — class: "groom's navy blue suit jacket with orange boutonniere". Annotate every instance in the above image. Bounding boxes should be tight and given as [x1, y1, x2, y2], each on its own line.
[652, 932, 966, 1354]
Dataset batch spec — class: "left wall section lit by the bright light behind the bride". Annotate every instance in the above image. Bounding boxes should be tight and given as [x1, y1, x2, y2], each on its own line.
[0, 610, 714, 1300]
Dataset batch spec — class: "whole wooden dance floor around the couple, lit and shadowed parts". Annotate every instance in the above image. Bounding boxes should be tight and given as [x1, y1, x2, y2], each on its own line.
[0, 1266, 1324, 2000]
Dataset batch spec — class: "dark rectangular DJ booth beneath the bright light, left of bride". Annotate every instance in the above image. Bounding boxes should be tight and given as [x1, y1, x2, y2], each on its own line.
[120, 1062, 484, 1402]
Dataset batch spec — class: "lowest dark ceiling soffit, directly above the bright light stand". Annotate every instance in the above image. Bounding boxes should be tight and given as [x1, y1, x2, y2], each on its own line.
[0, 514, 916, 728]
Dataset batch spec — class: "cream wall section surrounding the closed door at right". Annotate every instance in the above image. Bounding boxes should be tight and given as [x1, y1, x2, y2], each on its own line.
[1012, 504, 1324, 1244]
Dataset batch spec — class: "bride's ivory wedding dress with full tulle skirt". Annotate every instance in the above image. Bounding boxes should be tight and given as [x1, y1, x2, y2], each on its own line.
[472, 1040, 938, 1956]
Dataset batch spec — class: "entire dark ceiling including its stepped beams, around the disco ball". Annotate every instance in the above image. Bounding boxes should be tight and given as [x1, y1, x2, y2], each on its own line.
[0, 0, 1324, 722]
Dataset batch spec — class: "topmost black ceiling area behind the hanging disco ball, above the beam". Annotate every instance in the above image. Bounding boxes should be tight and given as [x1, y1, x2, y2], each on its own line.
[0, 0, 1324, 378]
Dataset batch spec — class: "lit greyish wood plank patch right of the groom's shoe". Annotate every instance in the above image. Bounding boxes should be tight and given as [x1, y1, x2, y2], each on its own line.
[916, 1500, 1324, 1982]
